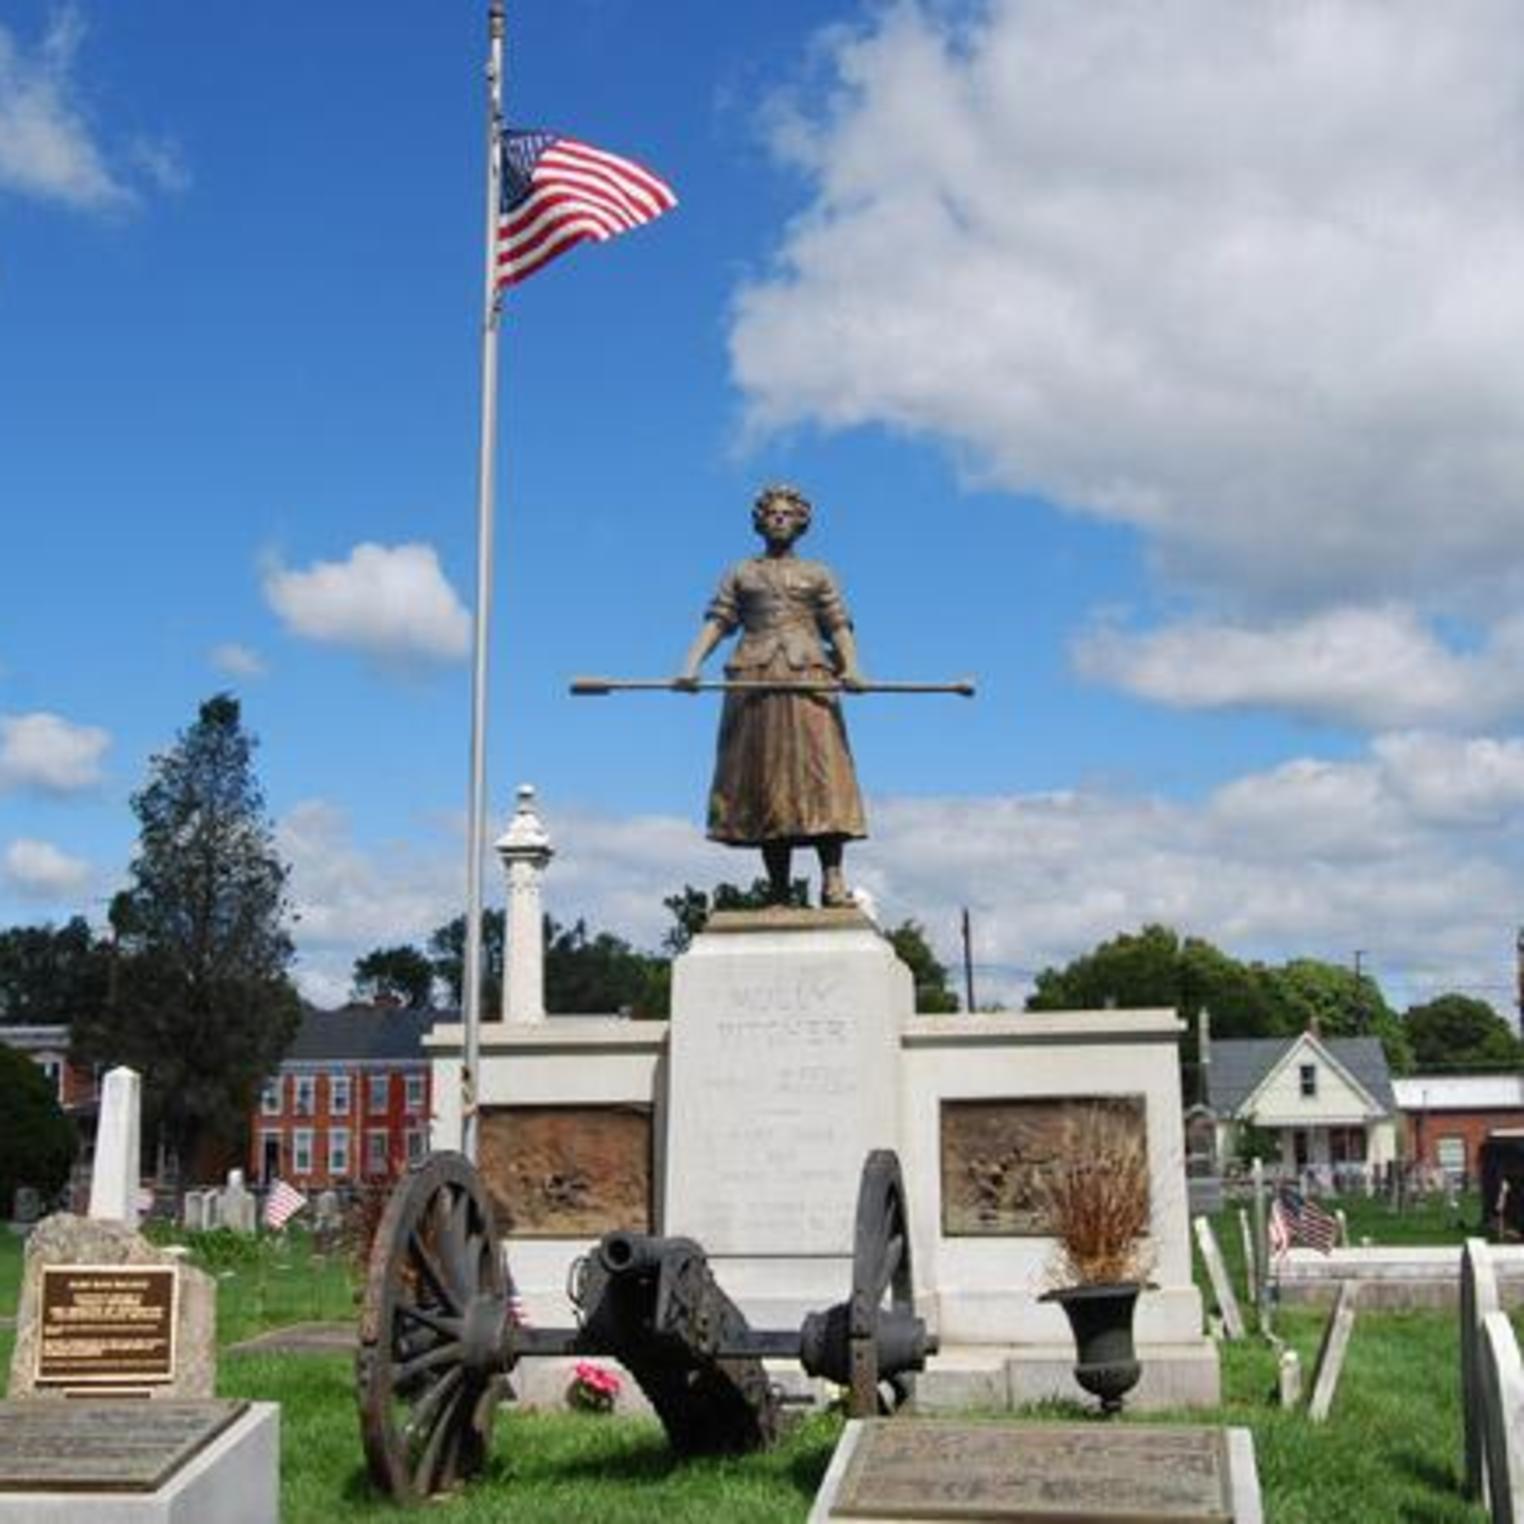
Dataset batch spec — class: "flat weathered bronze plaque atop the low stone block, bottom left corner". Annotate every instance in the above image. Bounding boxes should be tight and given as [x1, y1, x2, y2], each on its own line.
[0, 1401, 248, 1494]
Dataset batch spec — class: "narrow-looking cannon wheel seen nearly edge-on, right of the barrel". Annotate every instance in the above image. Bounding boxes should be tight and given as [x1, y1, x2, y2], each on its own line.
[847, 1148, 916, 1419]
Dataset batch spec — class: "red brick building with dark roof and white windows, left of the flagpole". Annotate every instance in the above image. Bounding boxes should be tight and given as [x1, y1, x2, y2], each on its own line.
[248, 1006, 438, 1190]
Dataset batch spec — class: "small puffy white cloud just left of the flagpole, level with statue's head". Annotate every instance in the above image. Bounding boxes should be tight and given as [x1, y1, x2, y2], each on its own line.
[264, 544, 471, 661]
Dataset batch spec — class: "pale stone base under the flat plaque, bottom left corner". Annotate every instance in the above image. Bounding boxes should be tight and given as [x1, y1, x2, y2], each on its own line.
[0, 1399, 280, 1524]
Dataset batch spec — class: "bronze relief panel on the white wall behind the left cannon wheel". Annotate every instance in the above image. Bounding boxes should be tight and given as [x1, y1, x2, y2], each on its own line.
[479, 1105, 654, 1237]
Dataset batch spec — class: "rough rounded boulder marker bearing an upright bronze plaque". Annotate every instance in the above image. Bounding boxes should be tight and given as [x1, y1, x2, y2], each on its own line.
[9, 1212, 216, 1399]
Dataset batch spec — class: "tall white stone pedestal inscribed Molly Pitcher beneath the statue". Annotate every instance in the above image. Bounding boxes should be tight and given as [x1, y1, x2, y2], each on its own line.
[663, 910, 914, 1327]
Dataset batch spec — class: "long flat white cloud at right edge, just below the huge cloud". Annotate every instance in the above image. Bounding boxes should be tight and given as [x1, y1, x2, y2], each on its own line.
[1074, 604, 1524, 730]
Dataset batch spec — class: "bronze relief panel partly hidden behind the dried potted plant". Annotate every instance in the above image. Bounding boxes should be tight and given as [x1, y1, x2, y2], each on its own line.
[940, 1096, 1148, 1237]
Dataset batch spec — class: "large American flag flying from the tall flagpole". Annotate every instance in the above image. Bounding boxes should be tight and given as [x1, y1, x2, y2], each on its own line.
[495, 128, 677, 290]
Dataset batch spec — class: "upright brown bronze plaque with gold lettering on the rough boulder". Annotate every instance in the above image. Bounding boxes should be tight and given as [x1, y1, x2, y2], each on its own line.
[37, 1265, 177, 1387]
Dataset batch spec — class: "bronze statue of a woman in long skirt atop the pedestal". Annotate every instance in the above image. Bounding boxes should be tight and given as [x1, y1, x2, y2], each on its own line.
[677, 486, 867, 905]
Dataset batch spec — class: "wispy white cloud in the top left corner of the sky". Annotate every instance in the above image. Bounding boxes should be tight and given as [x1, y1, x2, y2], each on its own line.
[0, 8, 134, 210]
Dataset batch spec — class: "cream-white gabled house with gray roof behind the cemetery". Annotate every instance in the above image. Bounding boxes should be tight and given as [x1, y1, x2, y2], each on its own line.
[1202, 1032, 1398, 1184]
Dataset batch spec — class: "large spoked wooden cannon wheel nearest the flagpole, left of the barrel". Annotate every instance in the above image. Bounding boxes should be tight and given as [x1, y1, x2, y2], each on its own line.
[355, 1154, 509, 1503]
